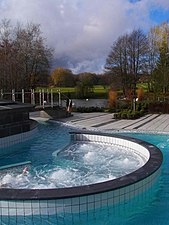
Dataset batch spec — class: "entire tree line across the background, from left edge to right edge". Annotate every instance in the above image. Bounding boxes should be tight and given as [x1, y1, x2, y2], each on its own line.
[0, 19, 169, 96]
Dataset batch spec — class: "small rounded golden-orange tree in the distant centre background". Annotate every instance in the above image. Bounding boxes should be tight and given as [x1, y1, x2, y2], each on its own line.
[51, 67, 75, 87]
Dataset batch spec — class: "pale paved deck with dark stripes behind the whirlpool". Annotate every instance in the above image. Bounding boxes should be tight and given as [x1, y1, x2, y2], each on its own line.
[55, 112, 169, 133]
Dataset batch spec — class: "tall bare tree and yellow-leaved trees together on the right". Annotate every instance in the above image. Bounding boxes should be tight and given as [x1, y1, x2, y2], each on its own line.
[105, 23, 169, 96]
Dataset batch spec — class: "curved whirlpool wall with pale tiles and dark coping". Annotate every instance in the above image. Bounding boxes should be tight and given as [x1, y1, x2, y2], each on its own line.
[0, 132, 163, 221]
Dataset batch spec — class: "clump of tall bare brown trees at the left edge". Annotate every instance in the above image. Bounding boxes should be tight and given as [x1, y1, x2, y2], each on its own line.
[0, 19, 52, 90]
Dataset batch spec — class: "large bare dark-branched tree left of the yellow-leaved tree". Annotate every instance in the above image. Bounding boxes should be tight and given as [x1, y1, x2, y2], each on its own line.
[105, 29, 148, 109]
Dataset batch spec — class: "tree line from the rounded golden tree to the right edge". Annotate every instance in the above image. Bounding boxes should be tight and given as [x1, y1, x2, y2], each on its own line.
[51, 23, 169, 97]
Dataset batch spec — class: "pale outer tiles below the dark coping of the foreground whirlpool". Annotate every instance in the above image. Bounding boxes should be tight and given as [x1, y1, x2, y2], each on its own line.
[0, 170, 159, 216]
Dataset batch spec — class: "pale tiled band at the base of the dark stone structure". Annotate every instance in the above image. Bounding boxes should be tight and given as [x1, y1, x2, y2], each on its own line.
[0, 128, 37, 148]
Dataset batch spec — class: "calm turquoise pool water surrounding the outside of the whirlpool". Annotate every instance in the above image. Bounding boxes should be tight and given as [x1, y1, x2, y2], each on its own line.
[0, 123, 166, 225]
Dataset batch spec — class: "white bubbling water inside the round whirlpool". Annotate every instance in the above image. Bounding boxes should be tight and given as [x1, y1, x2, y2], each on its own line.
[0, 143, 145, 189]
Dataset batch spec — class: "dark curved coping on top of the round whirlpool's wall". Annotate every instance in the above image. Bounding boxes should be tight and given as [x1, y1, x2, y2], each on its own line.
[0, 132, 163, 200]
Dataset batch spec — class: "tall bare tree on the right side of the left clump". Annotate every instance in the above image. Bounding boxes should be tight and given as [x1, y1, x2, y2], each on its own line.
[14, 24, 52, 88]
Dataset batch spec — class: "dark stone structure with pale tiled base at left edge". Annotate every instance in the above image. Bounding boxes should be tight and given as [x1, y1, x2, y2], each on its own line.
[0, 100, 37, 148]
